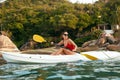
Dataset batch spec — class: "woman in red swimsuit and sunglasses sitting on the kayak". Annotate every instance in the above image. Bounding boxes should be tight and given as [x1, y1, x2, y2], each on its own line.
[52, 32, 77, 55]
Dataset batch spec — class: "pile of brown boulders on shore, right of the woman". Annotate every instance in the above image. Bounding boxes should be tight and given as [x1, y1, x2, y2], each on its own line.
[78, 30, 120, 51]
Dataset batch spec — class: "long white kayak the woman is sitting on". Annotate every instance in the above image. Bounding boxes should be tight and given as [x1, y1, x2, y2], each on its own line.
[2, 51, 120, 63]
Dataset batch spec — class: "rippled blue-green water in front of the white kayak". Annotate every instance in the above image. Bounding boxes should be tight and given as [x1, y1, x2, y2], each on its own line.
[0, 61, 120, 80]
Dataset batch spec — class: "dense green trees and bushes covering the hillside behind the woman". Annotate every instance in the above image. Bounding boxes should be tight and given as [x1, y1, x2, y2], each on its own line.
[0, 0, 120, 47]
